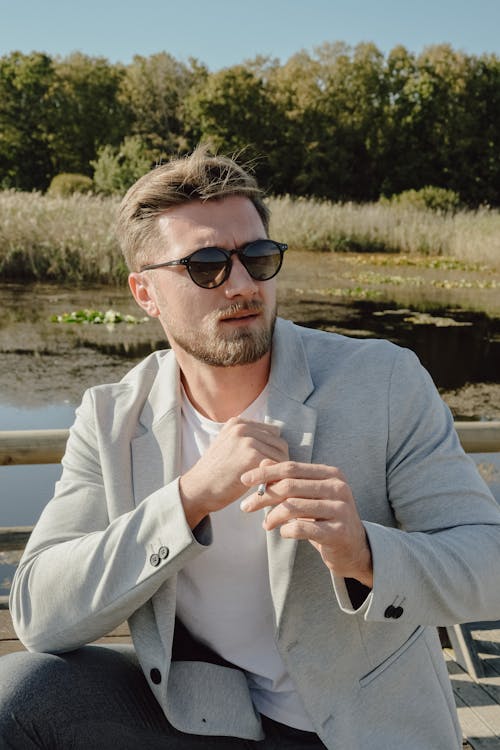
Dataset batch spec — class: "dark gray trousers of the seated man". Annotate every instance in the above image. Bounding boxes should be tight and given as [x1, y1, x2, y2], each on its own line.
[0, 645, 325, 750]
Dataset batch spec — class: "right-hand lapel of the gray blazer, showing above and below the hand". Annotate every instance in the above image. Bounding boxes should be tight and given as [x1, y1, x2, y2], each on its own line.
[266, 319, 316, 626]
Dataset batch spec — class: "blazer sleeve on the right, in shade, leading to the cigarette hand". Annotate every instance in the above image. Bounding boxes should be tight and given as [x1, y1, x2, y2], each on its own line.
[333, 350, 500, 625]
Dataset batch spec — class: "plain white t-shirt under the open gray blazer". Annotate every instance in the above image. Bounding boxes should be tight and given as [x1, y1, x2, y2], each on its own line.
[177, 388, 314, 731]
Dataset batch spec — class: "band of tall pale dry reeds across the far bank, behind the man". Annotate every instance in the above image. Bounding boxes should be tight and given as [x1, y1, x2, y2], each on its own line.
[0, 191, 500, 284]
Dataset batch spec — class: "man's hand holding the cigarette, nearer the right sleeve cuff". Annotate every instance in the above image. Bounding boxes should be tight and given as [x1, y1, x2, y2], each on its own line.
[241, 461, 373, 588]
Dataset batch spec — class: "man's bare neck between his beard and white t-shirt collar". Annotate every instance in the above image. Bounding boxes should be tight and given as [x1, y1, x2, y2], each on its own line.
[178, 353, 271, 422]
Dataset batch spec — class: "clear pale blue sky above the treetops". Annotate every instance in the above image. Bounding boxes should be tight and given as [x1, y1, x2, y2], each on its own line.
[0, 0, 500, 71]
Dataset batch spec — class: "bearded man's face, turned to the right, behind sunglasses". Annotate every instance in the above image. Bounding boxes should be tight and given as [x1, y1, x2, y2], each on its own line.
[129, 196, 276, 367]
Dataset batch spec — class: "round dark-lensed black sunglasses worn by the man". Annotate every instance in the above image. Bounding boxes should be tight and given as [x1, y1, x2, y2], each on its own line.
[141, 240, 288, 289]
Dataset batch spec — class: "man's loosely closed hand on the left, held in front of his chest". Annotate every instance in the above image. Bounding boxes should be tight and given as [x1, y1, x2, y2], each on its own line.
[179, 417, 288, 528]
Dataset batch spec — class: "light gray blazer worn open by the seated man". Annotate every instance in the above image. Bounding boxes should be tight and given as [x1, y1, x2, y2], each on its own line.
[11, 320, 500, 750]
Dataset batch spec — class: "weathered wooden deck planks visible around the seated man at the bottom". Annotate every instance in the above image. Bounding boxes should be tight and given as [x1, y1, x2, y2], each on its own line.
[0, 609, 500, 750]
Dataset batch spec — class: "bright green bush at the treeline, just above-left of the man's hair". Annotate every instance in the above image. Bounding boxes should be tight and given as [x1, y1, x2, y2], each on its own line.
[91, 136, 151, 195]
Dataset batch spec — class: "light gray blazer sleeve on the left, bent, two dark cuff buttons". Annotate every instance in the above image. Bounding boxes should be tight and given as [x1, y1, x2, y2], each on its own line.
[10, 392, 211, 652]
